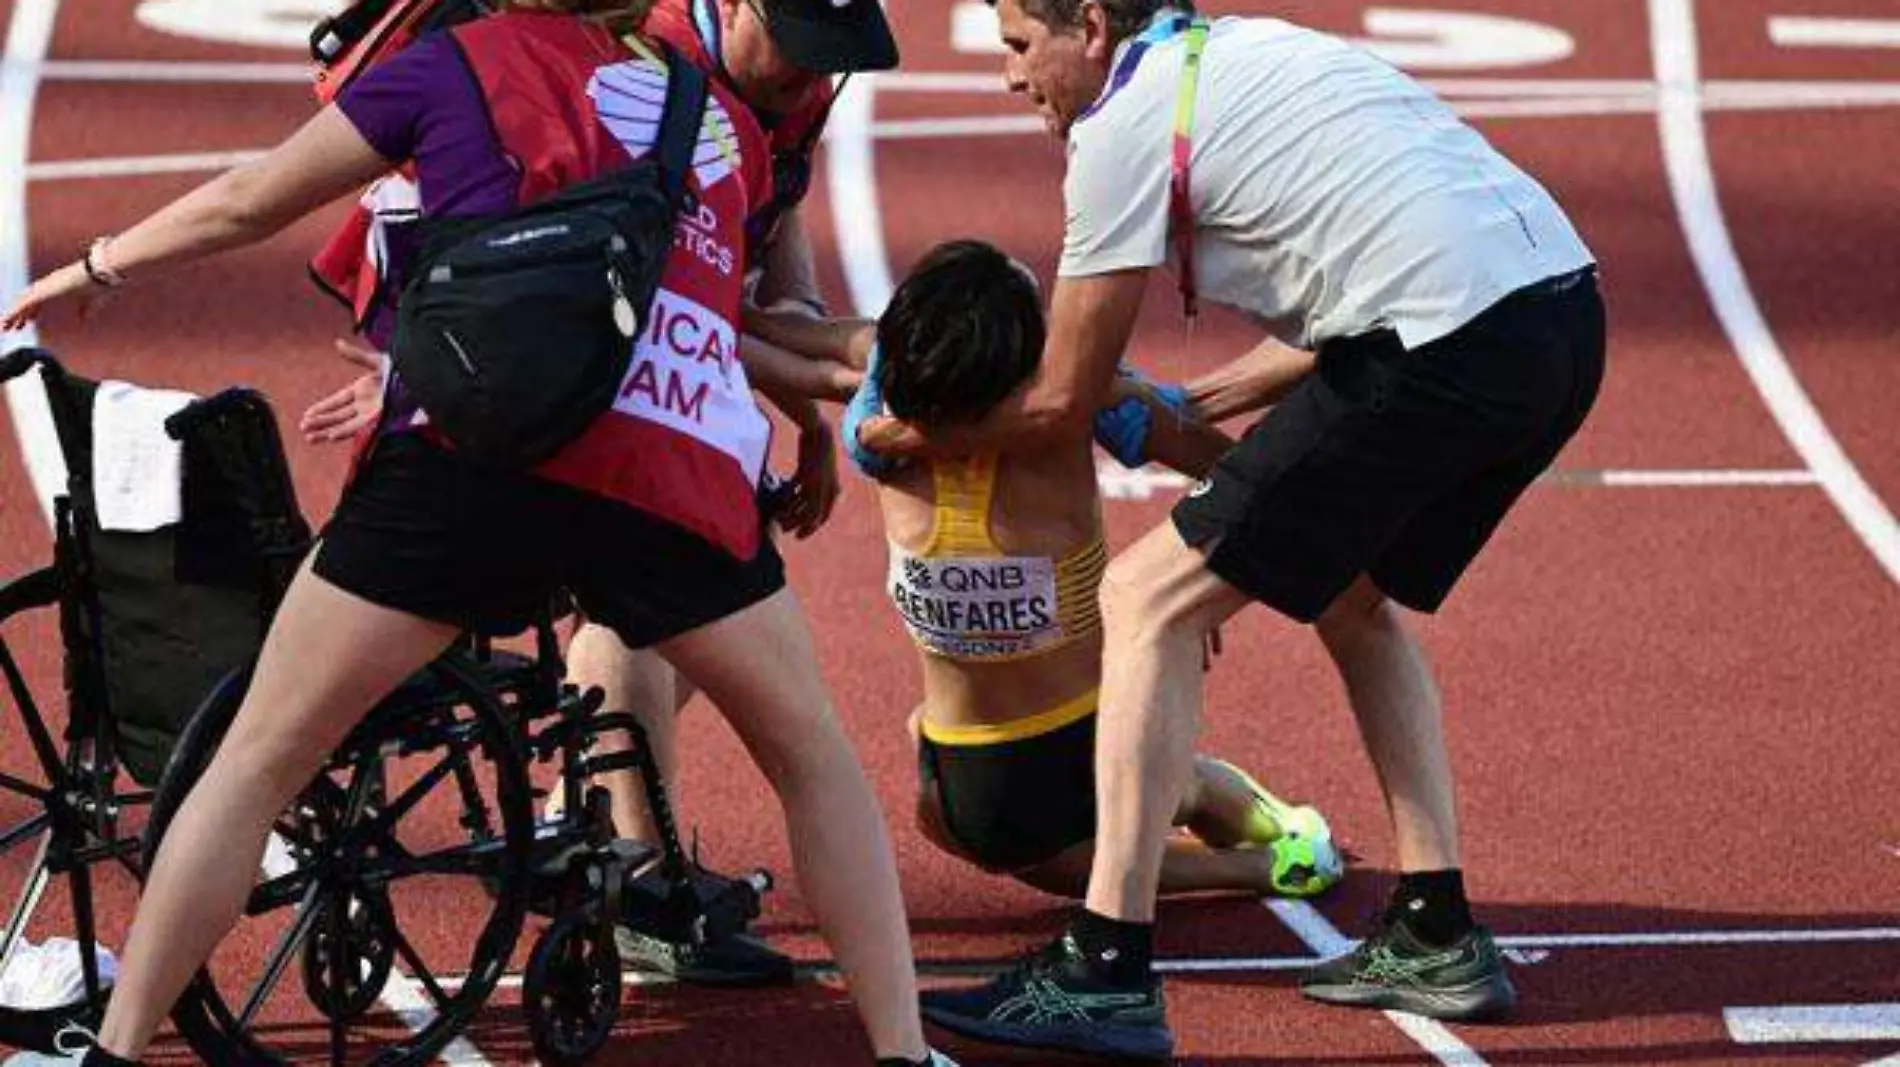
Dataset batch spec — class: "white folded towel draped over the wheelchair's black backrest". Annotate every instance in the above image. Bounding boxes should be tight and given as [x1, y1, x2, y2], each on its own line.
[93, 382, 198, 534]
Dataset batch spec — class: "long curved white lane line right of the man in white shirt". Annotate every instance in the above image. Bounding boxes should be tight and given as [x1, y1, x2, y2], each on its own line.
[1649, 0, 1900, 583]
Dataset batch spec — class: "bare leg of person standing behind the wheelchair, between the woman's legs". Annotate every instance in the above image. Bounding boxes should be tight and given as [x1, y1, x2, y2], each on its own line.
[568, 623, 695, 841]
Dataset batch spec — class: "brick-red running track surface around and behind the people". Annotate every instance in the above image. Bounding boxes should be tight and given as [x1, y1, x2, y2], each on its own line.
[0, 0, 1900, 1065]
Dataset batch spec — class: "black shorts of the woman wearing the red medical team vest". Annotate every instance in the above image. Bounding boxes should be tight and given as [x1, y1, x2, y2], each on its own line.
[314, 433, 785, 647]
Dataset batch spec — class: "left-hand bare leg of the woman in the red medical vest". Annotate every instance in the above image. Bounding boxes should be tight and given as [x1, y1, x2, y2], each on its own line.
[99, 570, 456, 1059]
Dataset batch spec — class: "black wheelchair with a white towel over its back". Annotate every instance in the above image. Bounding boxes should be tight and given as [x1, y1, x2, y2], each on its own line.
[0, 349, 771, 1067]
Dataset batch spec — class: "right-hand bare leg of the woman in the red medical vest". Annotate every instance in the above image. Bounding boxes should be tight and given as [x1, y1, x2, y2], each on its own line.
[659, 589, 925, 1059]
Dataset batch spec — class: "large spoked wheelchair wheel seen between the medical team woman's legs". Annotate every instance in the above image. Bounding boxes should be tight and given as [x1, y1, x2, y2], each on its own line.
[146, 657, 534, 1067]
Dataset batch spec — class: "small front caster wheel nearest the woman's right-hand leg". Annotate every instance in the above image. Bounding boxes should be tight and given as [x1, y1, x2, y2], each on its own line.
[521, 911, 621, 1067]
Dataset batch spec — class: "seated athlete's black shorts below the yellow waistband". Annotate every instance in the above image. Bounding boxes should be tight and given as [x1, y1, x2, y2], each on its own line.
[918, 710, 1094, 871]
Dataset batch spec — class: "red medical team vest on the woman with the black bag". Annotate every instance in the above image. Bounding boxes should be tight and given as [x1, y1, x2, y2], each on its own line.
[452, 13, 771, 558]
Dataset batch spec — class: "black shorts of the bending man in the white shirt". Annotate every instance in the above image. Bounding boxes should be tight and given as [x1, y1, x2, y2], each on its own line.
[1174, 271, 1604, 623]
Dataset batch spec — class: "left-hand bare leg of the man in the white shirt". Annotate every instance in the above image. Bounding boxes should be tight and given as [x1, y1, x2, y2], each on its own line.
[1087, 522, 1246, 923]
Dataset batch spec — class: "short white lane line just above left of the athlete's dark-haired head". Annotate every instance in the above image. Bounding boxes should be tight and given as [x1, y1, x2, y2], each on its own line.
[825, 74, 893, 317]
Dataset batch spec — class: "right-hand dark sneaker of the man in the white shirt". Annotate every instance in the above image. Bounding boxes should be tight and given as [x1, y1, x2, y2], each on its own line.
[1300, 923, 1518, 1020]
